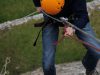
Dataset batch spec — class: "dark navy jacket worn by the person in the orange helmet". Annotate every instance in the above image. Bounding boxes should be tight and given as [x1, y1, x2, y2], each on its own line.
[33, 0, 89, 28]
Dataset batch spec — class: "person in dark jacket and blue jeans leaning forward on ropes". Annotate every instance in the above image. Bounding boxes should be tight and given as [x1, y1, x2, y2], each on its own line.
[33, 0, 100, 75]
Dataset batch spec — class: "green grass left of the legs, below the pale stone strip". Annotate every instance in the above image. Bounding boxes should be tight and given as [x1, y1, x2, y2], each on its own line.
[0, 22, 41, 75]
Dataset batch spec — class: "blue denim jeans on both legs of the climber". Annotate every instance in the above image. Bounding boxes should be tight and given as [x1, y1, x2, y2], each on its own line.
[42, 23, 100, 75]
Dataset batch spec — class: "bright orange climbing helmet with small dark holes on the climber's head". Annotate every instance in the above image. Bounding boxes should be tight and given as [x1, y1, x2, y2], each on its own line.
[40, 0, 65, 15]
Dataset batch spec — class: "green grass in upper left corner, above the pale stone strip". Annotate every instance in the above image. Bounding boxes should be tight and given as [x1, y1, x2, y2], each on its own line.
[0, 0, 35, 23]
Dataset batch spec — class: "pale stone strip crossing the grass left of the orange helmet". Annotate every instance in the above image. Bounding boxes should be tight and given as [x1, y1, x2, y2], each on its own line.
[0, 14, 43, 30]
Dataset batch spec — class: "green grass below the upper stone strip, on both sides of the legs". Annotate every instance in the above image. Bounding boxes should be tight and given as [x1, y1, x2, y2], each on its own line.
[0, 11, 100, 75]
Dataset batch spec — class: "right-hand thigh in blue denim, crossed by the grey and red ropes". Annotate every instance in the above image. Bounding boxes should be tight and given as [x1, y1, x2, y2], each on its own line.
[76, 23, 100, 56]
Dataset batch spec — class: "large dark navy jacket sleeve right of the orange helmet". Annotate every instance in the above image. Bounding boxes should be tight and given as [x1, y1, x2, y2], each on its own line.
[72, 0, 89, 28]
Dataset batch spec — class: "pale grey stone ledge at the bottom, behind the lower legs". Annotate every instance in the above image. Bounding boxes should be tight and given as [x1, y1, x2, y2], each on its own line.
[21, 61, 100, 75]
